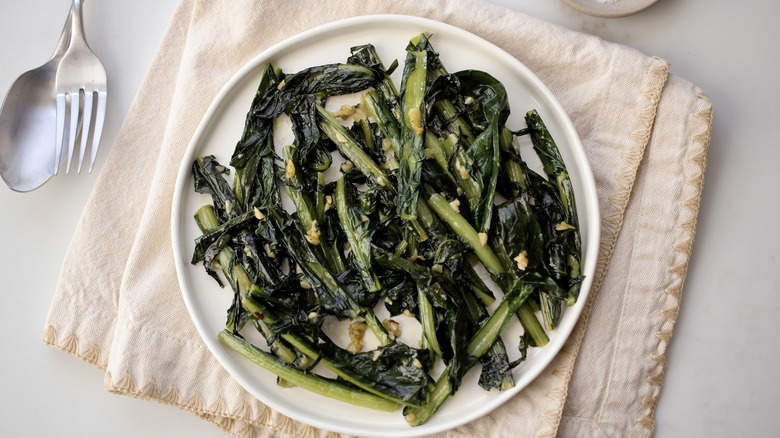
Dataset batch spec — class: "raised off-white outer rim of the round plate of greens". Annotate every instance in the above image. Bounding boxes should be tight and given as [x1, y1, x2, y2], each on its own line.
[171, 14, 600, 437]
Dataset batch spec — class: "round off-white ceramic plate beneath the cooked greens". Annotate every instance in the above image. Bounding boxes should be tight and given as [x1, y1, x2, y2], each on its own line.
[172, 15, 599, 437]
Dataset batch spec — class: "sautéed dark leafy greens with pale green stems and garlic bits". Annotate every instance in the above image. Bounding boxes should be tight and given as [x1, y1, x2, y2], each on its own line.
[192, 35, 583, 426]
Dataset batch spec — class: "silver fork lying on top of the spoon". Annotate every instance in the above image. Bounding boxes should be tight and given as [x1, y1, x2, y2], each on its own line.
[54, 0, 108, 175]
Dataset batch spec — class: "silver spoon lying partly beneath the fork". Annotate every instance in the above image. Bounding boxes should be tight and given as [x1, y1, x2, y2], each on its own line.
[0, 9, 73, 192]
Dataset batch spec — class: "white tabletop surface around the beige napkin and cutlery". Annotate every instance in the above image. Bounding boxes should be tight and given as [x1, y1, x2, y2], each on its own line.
[0, 0, 780, 438]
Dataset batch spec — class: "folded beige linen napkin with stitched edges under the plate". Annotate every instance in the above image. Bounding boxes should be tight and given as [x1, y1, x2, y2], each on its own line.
[44, 0, 712, 437]
